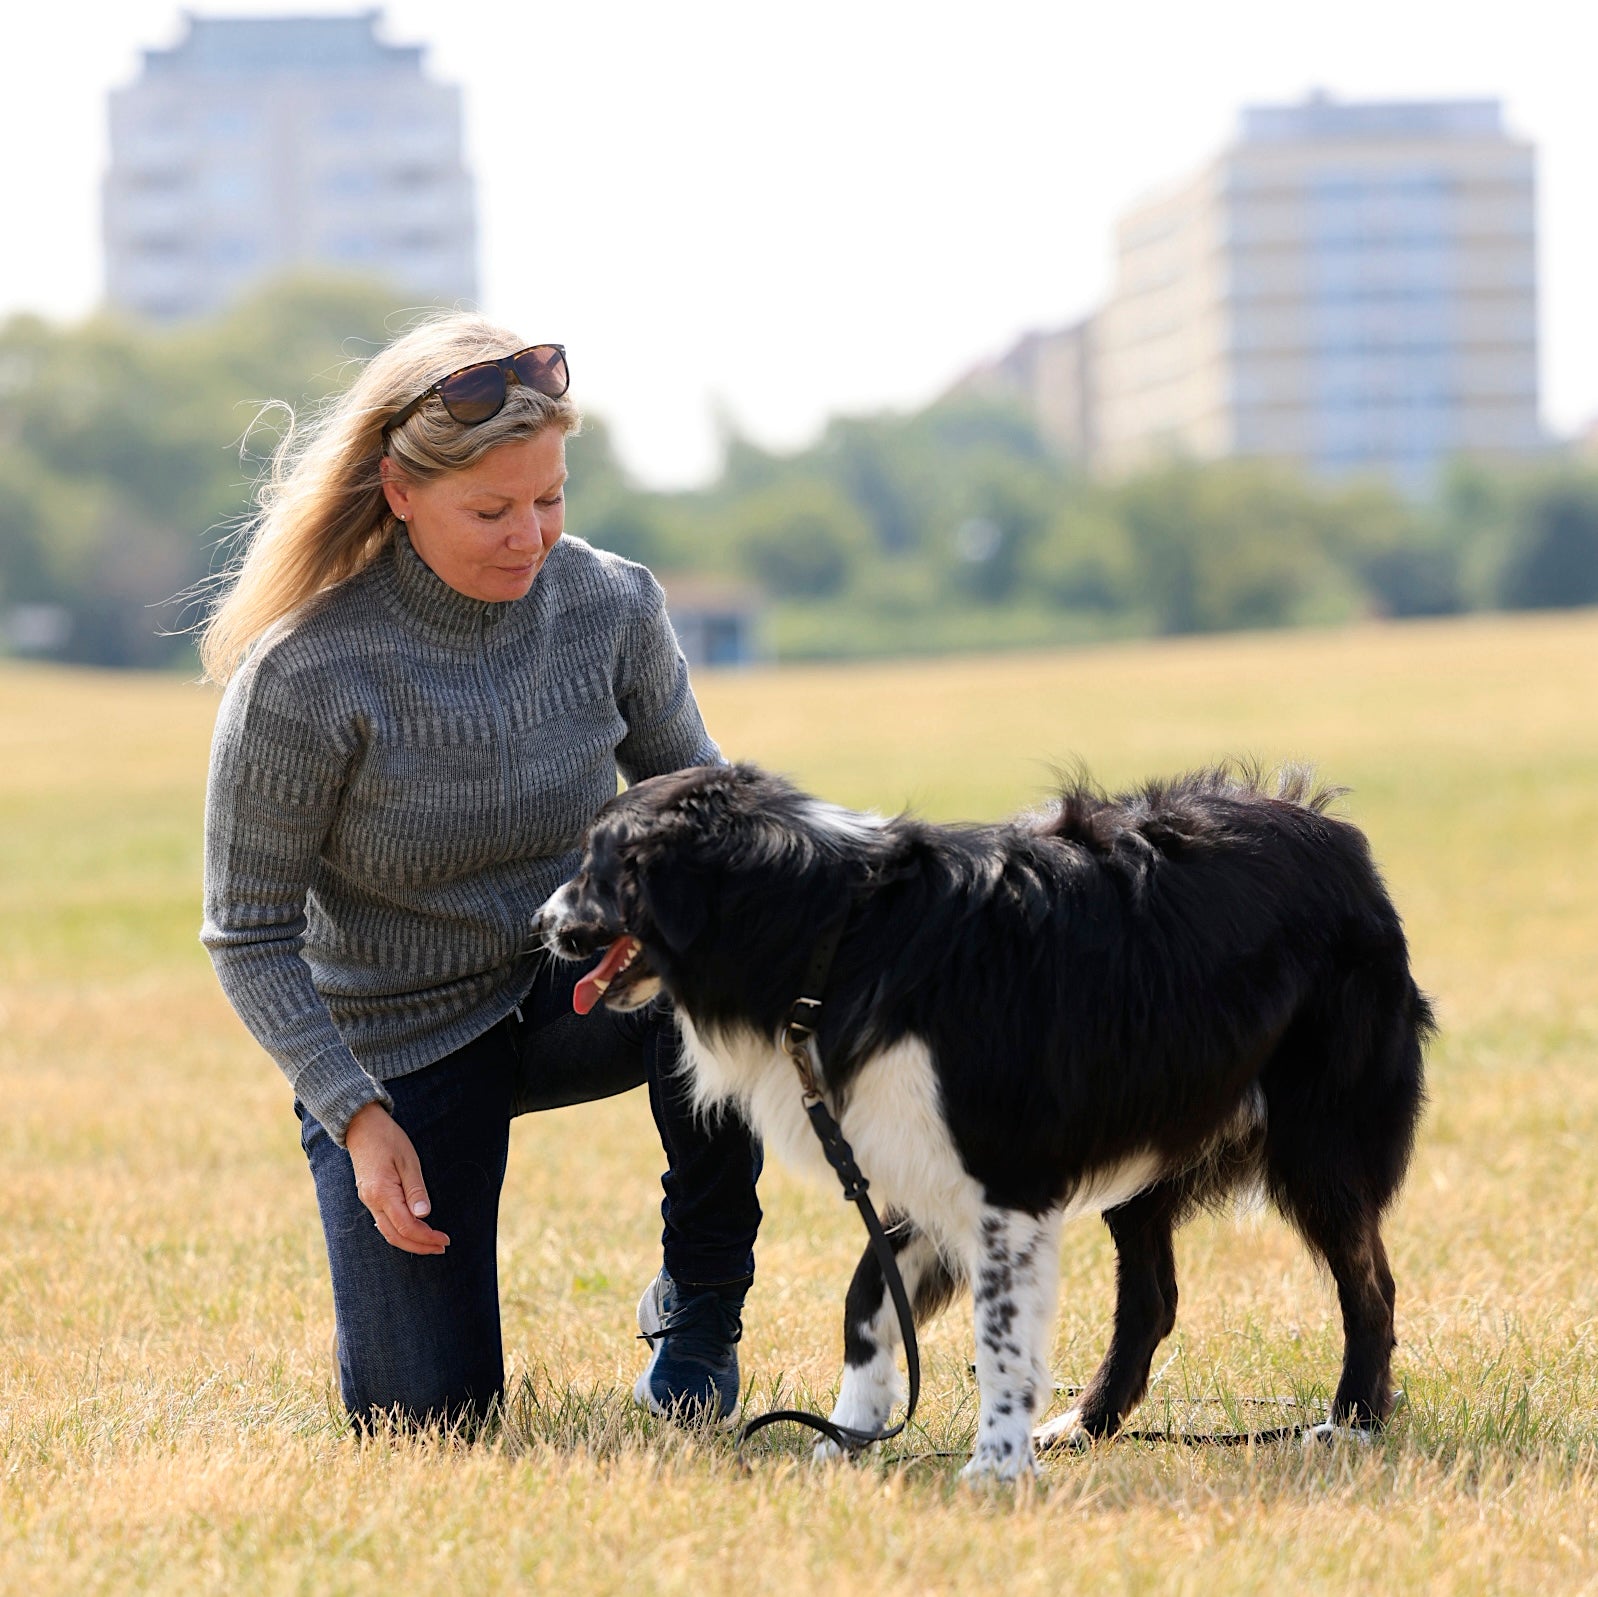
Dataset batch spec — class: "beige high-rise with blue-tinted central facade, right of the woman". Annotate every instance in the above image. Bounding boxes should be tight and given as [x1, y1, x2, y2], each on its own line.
[1091, 96, 1542, 489]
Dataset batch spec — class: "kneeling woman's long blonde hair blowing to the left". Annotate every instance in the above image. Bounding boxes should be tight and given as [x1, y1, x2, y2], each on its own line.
[200, 313, 578, 683]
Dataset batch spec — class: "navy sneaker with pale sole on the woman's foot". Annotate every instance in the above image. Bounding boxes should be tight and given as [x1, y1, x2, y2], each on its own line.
[633, 1269, 749, 1428]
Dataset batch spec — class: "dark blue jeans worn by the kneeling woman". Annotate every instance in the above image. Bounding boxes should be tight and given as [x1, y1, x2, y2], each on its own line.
[303, 966, 761, 1424]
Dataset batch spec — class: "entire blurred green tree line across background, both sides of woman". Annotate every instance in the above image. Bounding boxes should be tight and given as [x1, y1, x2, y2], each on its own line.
[0, 280, 1598, 665]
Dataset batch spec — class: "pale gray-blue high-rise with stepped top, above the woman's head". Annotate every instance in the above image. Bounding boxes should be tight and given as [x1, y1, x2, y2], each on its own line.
[104, 11, 476, 320]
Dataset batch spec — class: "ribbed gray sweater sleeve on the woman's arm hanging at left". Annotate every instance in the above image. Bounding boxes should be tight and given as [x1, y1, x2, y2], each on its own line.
[200, 655, 392, 1143]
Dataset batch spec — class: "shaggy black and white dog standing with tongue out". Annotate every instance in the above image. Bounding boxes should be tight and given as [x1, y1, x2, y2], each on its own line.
[540, 766, 1432, 1479]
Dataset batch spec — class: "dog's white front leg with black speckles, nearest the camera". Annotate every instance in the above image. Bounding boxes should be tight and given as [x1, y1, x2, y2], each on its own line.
[960, 1205, 1061, 1480]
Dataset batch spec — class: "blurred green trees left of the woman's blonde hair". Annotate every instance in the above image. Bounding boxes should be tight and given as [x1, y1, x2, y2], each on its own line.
[0, 281, 392, 665]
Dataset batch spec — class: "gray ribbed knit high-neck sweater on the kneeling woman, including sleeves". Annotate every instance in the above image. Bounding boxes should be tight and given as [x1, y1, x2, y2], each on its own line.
[200, 529, 719, 1141]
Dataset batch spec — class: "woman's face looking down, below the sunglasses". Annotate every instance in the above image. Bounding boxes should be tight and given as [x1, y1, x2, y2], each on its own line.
[382, 427, 566, 603]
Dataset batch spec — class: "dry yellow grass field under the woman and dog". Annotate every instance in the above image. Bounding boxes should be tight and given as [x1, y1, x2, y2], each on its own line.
[0, 612, 1598, 1597]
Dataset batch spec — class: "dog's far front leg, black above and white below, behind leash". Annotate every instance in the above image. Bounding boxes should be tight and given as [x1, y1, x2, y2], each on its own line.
[815, 1213, 960, 1458]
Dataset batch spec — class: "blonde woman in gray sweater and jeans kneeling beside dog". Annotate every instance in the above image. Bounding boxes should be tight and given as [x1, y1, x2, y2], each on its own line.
[201, 315, 761, 1424]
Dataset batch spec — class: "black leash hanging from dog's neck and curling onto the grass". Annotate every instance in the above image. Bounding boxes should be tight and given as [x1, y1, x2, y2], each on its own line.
[738, 898, 920, 1453]
